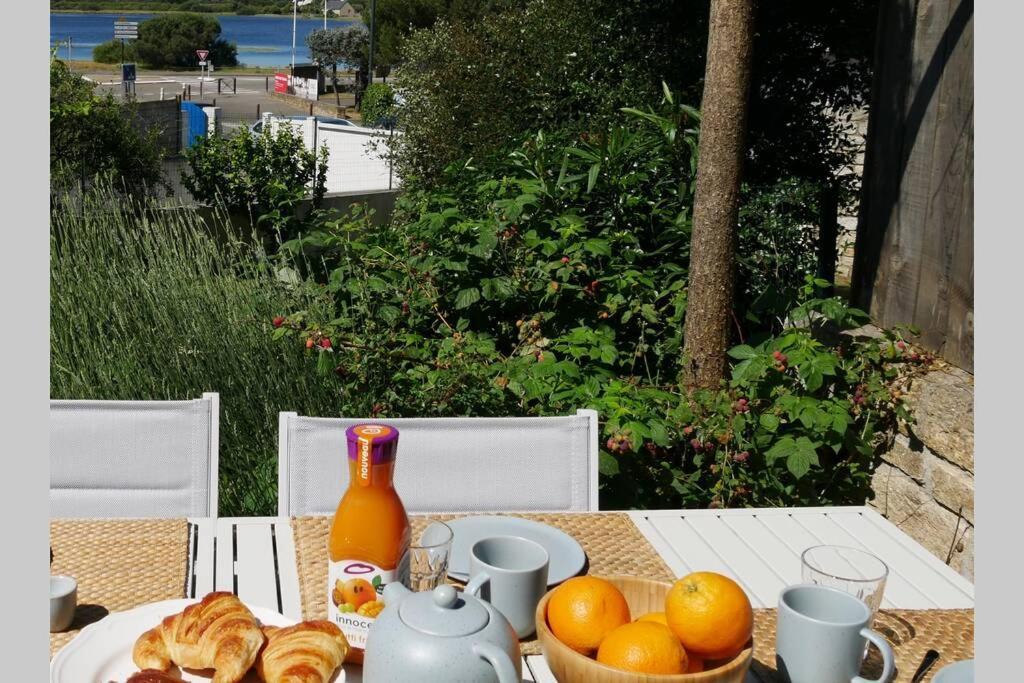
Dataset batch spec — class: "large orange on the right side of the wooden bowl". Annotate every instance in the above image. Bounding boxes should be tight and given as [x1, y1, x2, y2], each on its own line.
[665, 571, 754, 659]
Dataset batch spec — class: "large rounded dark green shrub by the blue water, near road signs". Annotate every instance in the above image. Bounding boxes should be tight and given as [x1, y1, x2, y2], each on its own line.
[135, 13, 239, 68]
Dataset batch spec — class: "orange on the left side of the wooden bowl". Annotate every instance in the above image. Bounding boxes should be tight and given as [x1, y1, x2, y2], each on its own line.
[548, 577, 630, 656]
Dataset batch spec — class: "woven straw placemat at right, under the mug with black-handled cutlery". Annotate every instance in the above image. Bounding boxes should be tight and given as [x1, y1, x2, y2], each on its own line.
[751, 609, 974, 683]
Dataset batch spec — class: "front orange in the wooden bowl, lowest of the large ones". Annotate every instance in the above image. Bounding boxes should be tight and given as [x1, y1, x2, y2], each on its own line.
[597, 622, 686, 674]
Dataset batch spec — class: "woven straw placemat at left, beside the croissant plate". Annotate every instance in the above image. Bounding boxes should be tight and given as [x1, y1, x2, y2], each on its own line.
[50, 519, 188, 657]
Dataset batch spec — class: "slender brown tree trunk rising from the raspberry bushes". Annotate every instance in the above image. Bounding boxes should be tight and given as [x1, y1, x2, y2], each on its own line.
[682, 0, 754, 389]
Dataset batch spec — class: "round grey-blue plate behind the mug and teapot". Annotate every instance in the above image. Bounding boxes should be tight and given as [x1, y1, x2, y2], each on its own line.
[446, 517, 587, 586]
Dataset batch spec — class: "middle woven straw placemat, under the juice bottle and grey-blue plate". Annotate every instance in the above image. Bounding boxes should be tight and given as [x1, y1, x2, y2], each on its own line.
[292, 512, 673, 654]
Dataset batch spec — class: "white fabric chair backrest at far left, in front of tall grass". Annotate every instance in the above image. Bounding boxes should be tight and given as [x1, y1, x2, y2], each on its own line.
[50, 393, 219, 517]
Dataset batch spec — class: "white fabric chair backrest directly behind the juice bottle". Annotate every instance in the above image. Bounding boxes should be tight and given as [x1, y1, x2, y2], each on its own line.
[278, 411, 598, 516]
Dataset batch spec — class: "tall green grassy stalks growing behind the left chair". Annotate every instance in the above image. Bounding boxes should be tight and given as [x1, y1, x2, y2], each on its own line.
[50, 188, 342, 515]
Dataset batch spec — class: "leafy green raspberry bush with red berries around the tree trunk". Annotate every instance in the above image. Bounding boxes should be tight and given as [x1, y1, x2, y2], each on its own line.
[266, 97, 924, 507]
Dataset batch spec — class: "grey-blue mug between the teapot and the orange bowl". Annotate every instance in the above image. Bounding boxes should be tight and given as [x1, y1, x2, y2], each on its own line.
[466, 536, 549, 638]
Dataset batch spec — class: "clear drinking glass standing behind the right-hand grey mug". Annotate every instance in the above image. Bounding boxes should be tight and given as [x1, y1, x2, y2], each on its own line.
[800, 546, 889, 625]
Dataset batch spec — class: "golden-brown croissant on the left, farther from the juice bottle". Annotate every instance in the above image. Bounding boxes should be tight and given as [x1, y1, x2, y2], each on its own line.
[132, 592, 265, 683]
